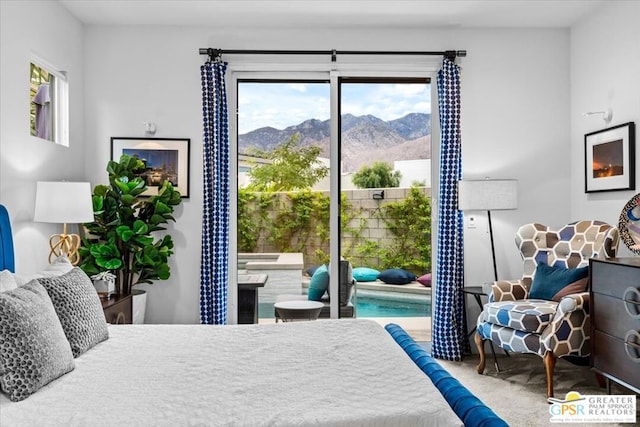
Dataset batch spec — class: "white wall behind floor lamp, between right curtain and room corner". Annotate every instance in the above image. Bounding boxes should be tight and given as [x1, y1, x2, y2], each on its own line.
[455, 30, 571, 285]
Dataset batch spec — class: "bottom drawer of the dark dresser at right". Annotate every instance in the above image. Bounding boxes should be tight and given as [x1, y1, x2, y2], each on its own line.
[591, 331, 640, 393]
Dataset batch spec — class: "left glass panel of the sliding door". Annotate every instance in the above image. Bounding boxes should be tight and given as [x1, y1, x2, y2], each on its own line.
[236, 79, 331, 322]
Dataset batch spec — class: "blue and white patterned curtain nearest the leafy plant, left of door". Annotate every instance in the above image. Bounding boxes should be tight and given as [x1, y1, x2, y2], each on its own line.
[200, 60, 229, 325]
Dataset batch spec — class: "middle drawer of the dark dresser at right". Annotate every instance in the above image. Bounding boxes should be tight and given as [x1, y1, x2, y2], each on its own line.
[591, 294, 640, 338]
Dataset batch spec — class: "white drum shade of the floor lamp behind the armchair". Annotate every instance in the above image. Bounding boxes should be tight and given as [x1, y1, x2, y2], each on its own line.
[458, 179, 518, 211]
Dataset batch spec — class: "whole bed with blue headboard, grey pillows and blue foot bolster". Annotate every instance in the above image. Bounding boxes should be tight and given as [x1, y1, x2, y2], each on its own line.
[0, 205, 506, 427]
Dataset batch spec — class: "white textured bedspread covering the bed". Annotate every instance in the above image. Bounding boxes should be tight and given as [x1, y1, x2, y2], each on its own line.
[0, 319, 462, 427]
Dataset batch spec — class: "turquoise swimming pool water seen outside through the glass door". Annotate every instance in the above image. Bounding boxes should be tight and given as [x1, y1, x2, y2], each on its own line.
[258, 290, 431, 319]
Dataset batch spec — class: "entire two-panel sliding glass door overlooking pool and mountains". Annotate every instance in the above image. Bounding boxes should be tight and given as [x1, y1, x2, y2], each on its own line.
[230, 73, 432, 340]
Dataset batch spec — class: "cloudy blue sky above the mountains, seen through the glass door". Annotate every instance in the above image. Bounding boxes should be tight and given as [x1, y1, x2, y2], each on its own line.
[238, 82, 431, 134]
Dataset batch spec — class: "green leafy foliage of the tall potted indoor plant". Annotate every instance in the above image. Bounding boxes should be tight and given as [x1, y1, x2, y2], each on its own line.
[80, 154, 182, 294]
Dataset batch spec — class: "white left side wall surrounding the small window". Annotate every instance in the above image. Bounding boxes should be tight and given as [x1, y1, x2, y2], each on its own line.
[0, 1, 85, 273]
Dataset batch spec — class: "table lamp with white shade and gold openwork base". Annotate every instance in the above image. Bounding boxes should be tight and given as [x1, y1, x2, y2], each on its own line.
[33, 181, 93, 265]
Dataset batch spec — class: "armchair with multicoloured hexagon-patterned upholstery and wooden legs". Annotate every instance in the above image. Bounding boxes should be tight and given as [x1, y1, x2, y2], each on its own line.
[475, 221, 619, 397]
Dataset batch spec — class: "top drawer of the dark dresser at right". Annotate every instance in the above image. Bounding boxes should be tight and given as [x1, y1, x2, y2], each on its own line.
[591, 260, 640, 298]
